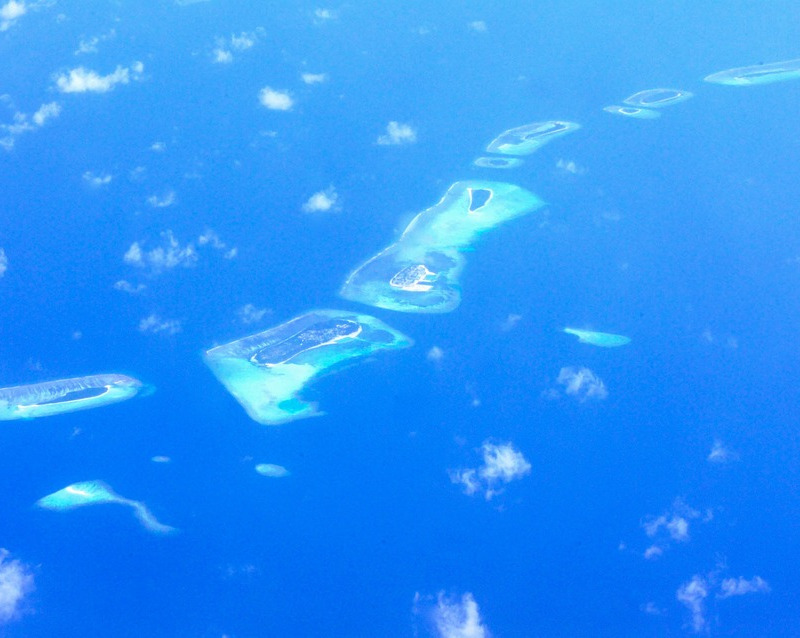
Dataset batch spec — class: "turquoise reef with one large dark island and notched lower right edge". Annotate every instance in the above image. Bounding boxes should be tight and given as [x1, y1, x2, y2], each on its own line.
[204, 310, 412, 425]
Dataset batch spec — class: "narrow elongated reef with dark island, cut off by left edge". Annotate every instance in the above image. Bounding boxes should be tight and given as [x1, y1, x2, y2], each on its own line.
[0, 374, 142, 421]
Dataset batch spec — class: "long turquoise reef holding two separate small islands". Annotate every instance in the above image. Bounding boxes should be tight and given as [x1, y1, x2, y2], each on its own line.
[339, 180, 544, 313]
